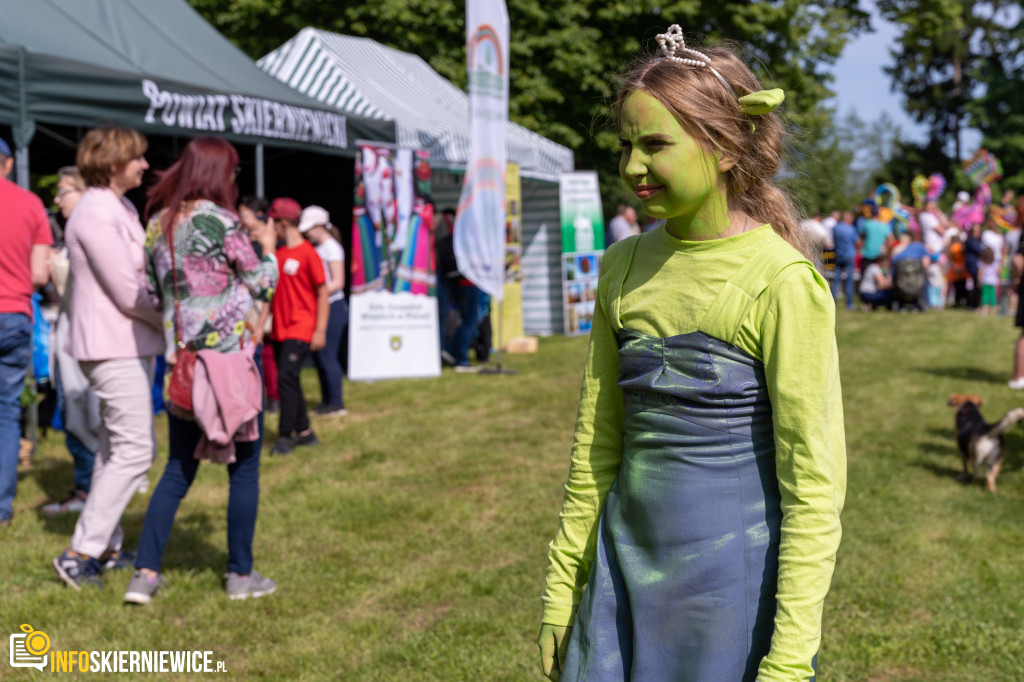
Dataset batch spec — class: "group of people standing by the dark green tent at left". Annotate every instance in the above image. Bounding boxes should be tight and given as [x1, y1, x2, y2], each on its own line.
[0, 127, 348, 604]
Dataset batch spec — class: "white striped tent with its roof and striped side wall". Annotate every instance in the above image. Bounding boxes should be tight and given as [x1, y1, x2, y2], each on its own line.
[257, 28, 574, 335]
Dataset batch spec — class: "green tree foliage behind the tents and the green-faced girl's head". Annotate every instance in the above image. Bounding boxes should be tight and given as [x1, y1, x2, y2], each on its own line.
[189, 0, 867, 212]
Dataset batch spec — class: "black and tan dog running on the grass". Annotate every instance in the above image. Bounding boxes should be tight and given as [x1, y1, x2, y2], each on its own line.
[946, 393, 1024, 493]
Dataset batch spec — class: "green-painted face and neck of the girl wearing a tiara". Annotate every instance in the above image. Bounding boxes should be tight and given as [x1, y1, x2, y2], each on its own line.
[618, 90, 729, 240]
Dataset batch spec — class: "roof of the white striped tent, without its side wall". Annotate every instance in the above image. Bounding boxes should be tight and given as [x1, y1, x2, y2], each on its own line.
[257, 28, 573, 182]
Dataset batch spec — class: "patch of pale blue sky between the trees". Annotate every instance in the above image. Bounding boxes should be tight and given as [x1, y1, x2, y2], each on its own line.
[828, 3, 981, 155]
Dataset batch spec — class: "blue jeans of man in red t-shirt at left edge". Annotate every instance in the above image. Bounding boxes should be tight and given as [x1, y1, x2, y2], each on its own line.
[0, 312, 32, 521]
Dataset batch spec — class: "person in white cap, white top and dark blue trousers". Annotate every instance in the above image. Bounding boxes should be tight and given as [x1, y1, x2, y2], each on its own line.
[299, 206, 348, 417]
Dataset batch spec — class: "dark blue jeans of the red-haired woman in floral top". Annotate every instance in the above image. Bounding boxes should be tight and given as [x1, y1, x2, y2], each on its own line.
[135, 414, 263, 574]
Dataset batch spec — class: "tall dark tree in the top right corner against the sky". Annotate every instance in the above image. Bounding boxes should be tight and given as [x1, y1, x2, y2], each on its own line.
[878, 0, 1021, 160]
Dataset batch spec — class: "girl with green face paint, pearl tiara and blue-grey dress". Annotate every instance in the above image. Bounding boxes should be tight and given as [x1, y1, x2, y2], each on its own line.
[539, 27, 846, 682]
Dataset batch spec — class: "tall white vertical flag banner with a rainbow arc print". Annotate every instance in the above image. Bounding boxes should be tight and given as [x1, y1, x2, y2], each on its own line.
[454, 0, 509, 301]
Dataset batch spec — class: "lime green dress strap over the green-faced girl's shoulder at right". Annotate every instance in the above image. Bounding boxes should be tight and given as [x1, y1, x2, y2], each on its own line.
[697, 237, 811, 344]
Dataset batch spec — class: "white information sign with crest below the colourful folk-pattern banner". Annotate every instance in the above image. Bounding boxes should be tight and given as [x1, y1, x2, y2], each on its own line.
[348, 291, 441, 381]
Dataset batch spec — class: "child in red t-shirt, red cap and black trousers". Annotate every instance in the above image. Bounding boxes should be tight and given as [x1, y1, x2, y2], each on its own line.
[266, 198, 330, 455]
